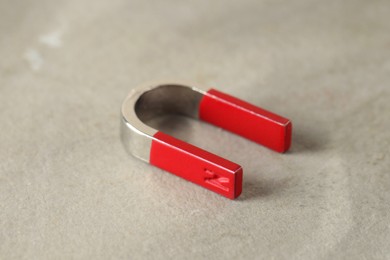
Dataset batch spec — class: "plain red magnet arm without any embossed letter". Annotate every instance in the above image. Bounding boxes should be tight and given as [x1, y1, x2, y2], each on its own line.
[199, 89, 292, 152]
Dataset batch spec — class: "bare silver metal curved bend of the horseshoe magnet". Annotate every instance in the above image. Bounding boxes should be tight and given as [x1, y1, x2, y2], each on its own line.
[121, 82, 206, 162]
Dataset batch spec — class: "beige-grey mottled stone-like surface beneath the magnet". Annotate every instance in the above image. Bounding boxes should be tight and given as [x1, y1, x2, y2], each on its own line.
[0, 0, 390, 259]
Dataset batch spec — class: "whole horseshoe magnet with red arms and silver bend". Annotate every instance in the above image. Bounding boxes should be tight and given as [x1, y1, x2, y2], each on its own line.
[121, 82, 292, 199]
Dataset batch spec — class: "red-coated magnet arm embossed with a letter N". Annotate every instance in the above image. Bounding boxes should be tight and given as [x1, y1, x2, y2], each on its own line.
[150, 132, 242, 199]
